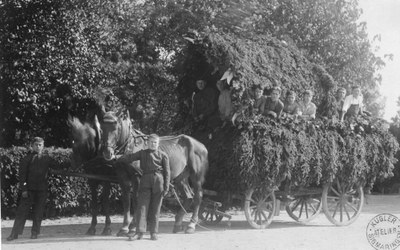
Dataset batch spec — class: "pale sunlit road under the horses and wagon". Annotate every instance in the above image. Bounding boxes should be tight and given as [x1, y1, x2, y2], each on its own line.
[1, 195, 400, 250]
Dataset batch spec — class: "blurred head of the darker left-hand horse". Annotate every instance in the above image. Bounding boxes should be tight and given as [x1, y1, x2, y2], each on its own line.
[68, 116, 101, 169]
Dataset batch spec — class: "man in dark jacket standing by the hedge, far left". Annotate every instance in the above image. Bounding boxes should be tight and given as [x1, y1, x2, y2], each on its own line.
[7, 137, 55, 241]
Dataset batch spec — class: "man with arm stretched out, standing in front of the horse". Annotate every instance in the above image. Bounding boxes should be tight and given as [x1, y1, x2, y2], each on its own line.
[118, 134, 170, 240]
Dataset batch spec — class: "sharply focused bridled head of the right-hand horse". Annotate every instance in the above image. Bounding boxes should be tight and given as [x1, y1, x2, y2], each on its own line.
[101, 111, 132, 161]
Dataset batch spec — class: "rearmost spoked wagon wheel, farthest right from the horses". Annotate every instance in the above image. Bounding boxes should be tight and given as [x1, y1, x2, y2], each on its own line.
[322, 180, 364, 226]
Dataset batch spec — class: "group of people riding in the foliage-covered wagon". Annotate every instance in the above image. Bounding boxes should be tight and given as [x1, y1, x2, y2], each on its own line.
[192, 80, 363, 132]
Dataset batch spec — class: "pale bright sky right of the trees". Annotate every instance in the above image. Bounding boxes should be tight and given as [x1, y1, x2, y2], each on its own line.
[358, 0, 400, 121]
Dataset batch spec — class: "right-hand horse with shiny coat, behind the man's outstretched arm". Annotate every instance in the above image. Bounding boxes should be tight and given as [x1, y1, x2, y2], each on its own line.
[101, 112, 208, 233]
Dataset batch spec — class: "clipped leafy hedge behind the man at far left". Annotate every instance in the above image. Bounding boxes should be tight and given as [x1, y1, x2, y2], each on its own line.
[0, 147, 122, 218]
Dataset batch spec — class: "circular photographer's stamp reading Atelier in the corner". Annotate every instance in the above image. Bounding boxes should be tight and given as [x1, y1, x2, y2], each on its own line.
[366, 213, 400, 250]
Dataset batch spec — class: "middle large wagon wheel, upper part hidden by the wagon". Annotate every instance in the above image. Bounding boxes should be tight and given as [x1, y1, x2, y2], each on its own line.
[286, 193, 322, 223]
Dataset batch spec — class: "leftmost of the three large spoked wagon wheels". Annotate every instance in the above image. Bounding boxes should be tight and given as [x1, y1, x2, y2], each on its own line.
[244, 188, 276, 229]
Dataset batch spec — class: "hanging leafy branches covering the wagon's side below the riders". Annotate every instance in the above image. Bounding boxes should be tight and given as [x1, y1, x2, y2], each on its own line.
[206, 116, 399, 193]
